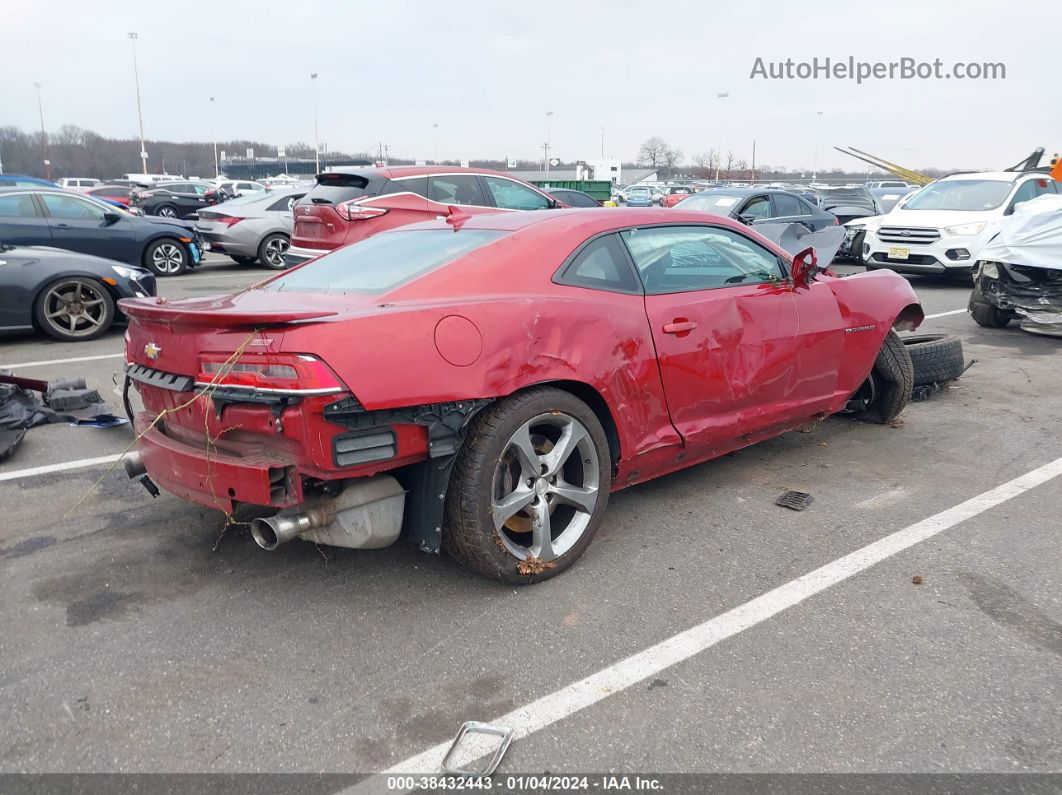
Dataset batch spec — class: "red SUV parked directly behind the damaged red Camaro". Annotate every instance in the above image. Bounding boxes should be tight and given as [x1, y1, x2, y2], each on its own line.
[285, 166, 561, 265]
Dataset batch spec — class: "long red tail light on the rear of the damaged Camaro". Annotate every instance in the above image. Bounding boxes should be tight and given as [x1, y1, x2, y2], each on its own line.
[195, 353, 349, 395]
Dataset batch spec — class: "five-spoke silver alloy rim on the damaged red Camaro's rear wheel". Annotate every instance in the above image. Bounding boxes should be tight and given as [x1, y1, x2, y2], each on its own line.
[491, 412, 600, 560]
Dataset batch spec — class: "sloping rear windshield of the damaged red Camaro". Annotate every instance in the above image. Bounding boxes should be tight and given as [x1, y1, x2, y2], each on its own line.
[262, 229, 509, 293]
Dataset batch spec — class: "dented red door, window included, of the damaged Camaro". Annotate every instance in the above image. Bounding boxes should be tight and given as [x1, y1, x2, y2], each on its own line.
[620, 225, 844, 454]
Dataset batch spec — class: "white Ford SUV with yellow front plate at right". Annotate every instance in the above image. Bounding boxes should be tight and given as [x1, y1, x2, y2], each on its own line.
[862, 171, 1060, 275]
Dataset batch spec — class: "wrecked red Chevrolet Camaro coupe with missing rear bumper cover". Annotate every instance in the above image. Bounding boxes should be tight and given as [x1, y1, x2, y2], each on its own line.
[121, 209, 923, 583]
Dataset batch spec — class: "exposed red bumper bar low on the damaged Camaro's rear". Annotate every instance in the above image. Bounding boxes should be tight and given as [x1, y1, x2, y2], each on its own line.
[136, 412, 303, 513]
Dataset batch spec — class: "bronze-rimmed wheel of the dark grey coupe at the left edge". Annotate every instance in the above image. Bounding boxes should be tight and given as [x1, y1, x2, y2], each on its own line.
[33, 276, 115, 342]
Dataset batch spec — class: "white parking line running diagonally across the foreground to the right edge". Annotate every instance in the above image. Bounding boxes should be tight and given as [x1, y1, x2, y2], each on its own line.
[345, 459, 1062, 781]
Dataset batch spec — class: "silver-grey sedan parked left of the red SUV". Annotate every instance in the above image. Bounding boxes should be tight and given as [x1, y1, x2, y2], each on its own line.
[195, 188, 306, 271]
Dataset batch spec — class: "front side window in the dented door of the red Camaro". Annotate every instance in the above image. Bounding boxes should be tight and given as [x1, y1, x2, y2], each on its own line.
[620, 226, 785, 295]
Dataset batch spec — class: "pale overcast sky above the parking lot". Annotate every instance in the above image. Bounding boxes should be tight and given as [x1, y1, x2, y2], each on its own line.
[0, 0, 1062, 169]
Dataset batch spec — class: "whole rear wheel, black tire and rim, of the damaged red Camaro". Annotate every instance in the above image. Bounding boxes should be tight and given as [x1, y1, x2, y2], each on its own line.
[443, 386, 612, 584]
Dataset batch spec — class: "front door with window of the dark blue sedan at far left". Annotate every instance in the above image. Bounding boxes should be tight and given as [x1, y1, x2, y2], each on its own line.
[39, 188, 136, 262]
